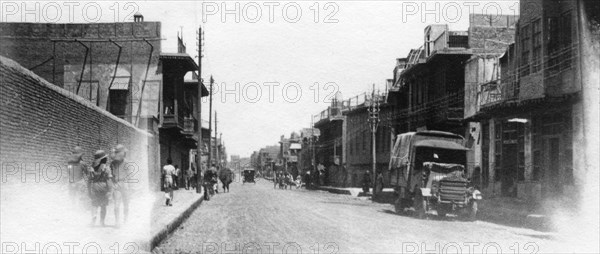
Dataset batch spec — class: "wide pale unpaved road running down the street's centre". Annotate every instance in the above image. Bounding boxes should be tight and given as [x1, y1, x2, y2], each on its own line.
[153, 179, 564, 253]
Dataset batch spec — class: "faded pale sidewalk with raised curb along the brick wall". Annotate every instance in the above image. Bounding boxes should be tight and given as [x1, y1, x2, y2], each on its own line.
[0, 184, 203, 253]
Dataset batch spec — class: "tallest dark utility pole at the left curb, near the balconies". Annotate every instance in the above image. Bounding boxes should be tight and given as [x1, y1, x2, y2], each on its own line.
[196, 27, 203, 193]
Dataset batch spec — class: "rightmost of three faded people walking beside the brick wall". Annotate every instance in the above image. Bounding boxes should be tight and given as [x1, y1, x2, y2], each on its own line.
[110, 144, 133, 227]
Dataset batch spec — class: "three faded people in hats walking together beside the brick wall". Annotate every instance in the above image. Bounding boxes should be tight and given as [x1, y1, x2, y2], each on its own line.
[67, 144, 137, 227]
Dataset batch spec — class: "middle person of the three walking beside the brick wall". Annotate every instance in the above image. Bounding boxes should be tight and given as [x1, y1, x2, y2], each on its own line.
[88, 150, 113, 227]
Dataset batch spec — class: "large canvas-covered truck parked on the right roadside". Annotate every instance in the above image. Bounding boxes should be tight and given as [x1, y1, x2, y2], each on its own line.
[389, 131, 481, 220]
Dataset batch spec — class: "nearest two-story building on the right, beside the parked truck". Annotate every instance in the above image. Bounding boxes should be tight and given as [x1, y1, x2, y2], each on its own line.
[465, 0, 600, 200]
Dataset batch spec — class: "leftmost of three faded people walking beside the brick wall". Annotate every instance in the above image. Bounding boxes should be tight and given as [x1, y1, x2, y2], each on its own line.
[67, 146, 90, 207]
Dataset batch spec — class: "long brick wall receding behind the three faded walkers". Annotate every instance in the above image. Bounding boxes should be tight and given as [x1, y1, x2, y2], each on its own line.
[0, 56, 159, 189]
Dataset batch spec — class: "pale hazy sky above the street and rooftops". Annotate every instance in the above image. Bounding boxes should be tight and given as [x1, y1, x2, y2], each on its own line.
[1, 1, 518, 157]
